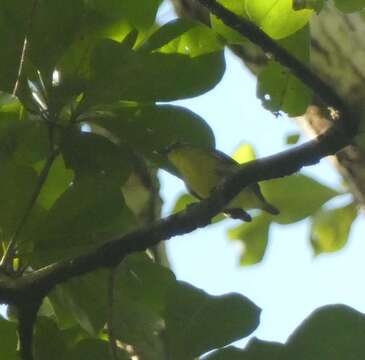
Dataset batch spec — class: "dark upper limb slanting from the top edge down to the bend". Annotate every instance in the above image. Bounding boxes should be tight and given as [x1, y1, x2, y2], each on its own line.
[196, 0, 358, 137]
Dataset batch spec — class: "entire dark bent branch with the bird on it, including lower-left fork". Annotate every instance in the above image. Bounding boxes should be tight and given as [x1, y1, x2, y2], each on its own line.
[0, 0, 358, 360]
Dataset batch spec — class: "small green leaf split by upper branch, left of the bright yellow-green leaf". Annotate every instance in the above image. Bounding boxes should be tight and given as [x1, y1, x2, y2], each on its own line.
[210, 0, 247, 45]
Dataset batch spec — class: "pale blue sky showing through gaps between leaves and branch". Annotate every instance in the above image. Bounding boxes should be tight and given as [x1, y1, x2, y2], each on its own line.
[161, 1, 365, 341]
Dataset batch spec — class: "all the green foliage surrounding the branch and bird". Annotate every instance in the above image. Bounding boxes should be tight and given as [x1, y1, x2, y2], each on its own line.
[0, 0, 365, 360]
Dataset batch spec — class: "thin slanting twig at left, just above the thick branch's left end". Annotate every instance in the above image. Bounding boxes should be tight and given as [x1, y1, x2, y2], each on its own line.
[0, 149, 59, 271]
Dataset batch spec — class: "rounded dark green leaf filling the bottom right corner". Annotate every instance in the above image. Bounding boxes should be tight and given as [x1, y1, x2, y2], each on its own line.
[285, 305, 365, 360]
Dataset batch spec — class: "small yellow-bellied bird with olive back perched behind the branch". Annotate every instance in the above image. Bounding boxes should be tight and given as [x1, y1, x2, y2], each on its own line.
[163, 143, 279, 221]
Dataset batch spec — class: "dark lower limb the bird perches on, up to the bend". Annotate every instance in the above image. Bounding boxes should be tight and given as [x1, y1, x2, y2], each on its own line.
[5, 126, 350, 302]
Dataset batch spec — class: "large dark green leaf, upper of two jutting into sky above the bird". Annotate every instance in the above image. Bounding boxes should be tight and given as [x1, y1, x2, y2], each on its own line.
[85, 40, 225, 104]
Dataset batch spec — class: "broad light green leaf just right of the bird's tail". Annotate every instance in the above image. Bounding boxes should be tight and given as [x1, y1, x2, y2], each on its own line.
[260, 175, 339, 224]
